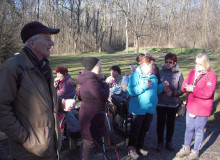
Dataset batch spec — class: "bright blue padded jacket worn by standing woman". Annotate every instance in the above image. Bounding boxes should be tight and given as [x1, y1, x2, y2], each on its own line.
[127, 66, 164, 115]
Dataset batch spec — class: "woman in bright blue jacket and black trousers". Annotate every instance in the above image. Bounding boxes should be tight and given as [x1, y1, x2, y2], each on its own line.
[127, 54, 164, 159]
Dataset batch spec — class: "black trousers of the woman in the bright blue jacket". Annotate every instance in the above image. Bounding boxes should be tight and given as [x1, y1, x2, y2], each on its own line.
[128, 113, 153, 149]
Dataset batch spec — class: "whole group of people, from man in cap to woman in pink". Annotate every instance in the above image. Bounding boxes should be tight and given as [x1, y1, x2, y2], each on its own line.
[0, 21, 217, 160]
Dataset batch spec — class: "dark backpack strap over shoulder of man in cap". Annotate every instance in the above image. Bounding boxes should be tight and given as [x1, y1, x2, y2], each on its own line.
[14, 53, 26, 90]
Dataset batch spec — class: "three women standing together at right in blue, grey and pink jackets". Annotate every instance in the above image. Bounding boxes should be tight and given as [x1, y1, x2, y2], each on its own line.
[105, 52, 217, 159]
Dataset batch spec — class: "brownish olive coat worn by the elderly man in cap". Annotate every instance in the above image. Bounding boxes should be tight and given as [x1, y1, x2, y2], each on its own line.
[0, 51, 62, 160]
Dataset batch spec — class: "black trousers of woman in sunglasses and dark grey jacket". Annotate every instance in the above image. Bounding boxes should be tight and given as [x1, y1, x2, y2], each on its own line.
[157, 107, 177, 143]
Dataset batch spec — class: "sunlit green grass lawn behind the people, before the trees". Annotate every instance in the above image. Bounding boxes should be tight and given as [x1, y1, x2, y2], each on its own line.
[49, 48, 220, 128]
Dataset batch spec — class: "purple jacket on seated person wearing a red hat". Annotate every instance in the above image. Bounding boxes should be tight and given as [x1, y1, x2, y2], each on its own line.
[57, 74, 76, 99]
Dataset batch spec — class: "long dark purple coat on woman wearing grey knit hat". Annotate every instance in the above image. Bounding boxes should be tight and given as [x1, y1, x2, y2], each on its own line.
[77, 70, 109, 140]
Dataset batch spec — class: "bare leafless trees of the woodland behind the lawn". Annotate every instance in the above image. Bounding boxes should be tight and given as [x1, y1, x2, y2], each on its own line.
[0, 0, 220, 62]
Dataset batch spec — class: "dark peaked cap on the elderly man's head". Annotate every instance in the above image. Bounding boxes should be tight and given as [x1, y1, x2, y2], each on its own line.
[21, 21, 60, 43]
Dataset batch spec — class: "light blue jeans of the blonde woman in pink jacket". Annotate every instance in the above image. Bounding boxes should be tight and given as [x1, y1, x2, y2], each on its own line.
[184, 111, 208, 150]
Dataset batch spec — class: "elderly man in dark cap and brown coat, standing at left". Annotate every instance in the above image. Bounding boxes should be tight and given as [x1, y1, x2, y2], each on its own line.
[0, 21, 74, 160]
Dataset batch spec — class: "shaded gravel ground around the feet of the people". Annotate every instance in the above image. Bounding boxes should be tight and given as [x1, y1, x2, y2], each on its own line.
[0, 115, 220, 160]
